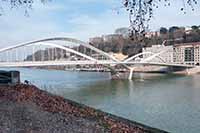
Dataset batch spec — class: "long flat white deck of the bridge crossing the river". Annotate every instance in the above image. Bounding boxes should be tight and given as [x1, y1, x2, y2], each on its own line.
[0, 60, 194, 68]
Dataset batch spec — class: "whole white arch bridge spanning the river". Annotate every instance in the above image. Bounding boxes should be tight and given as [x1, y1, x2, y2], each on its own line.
[0, 37, 193, 79]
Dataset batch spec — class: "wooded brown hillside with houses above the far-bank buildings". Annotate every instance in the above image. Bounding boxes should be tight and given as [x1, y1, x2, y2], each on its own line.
[90, 25, 200, 56]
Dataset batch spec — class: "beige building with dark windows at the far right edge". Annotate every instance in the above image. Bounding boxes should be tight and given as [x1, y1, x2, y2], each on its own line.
[173, 42, 200, 65]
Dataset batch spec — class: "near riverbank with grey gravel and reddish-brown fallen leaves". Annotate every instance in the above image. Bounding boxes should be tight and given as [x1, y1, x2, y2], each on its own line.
[0, 84, 164, 133]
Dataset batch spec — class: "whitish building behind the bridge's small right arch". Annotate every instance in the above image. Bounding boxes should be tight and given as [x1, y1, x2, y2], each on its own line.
[142, 45, 173, 63]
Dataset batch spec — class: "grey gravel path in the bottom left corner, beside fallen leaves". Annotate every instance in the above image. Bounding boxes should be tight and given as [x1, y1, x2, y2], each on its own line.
[0, 100, 106, 133]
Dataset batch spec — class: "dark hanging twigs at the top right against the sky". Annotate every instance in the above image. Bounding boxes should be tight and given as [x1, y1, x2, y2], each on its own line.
[123, 0, 199, 39]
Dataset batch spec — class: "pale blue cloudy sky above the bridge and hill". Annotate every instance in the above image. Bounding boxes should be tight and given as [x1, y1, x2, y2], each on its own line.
[0, 0, 200, 48]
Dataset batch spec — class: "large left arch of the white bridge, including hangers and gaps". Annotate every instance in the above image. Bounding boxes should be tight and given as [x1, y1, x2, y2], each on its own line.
[0, 38, 120, 69]
